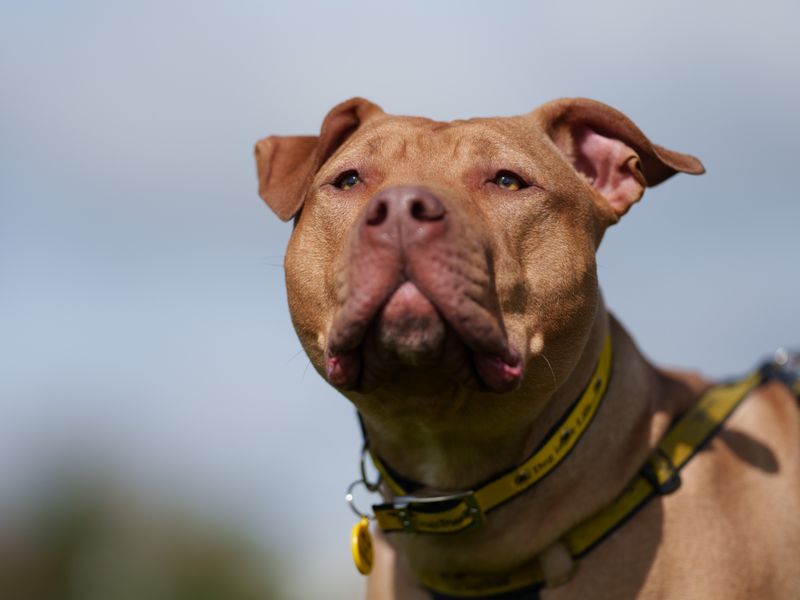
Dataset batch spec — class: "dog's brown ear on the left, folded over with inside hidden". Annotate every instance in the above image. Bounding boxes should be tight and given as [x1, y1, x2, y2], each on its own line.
[256, 98, 382, 221]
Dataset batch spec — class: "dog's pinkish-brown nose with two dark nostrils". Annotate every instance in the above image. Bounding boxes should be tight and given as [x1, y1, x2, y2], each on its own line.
[364, 185, 447, 242]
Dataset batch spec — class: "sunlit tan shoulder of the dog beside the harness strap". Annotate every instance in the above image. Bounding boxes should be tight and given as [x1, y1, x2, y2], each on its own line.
[604, 381, 800, 599]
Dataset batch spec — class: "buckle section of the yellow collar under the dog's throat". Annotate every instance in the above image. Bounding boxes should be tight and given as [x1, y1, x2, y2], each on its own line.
[382, 491, 484, 534]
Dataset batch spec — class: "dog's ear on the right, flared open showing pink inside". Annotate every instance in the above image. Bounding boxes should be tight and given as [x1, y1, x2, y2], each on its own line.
[533, 98, 705, 221]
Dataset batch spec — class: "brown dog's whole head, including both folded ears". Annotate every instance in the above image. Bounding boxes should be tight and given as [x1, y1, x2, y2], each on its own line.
[256, 99, 702, 432]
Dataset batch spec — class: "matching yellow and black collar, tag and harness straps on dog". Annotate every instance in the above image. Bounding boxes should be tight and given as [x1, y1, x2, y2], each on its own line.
[348, 336, 800, 600]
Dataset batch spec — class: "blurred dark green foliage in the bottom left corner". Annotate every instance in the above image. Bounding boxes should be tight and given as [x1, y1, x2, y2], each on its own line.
[0, 484, 281, 600]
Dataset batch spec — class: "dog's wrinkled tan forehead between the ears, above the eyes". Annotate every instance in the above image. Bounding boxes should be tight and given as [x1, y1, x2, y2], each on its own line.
[328, 116, 534, 166]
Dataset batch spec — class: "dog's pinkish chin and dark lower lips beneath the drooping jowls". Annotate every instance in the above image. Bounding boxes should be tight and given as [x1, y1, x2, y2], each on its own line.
[325, 281, 523, 395]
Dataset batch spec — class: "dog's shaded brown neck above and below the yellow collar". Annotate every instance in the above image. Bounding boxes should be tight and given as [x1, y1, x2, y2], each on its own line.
[360, 312, 701, 571]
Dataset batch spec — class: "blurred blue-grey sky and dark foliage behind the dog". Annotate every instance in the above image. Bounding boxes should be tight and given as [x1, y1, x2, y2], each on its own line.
[0, 0, 800, 600]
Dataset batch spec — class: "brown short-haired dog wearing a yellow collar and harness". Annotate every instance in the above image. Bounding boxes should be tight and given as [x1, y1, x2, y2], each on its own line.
[256, 98, 800, 600]
